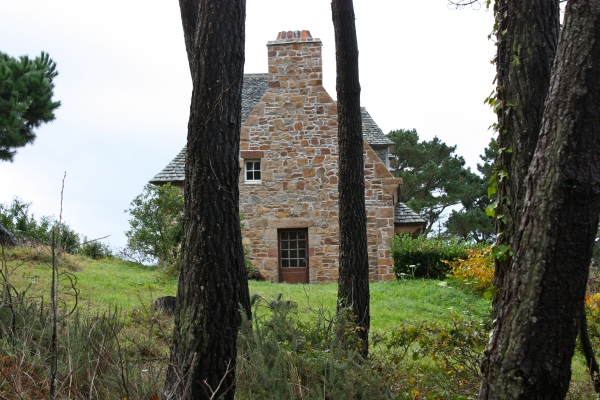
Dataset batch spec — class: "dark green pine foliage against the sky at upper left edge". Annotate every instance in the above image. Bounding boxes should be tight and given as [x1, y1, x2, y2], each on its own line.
[0, 52, 60, 161]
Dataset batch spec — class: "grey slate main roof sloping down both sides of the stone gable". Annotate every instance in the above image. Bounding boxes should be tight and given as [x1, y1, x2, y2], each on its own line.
[150, 74, 394, 185]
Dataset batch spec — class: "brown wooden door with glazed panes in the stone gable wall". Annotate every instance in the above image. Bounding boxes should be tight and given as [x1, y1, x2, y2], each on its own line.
[278, 229, 308, 283]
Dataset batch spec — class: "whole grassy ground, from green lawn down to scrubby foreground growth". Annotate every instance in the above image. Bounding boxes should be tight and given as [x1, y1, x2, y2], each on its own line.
[0, 247, 593, 399]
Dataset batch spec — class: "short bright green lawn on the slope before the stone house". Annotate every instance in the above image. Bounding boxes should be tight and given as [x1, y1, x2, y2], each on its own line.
[3, 249, 490, 331]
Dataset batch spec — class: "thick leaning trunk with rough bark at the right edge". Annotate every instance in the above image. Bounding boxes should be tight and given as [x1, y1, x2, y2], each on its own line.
[480, 0, 600, 399]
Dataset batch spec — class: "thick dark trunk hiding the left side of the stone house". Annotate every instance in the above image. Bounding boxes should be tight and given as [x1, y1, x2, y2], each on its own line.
[165, 0, 250, 399]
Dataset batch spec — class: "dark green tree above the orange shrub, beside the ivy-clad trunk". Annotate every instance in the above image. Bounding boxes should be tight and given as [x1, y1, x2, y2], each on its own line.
[445, 139, 499, 243]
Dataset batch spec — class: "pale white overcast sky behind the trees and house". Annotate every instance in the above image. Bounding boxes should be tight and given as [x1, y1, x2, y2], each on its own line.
[0, 0, 495, 246]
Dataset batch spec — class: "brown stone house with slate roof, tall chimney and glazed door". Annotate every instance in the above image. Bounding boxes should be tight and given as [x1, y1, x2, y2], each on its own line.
[150, 31, 410, 283]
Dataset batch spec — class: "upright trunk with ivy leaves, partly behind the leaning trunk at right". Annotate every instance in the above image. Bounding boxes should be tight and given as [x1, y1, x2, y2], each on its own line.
[494, 0, 560, 318]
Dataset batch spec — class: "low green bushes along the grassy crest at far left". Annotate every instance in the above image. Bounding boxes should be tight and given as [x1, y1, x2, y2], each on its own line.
[0, 197, 80, 254]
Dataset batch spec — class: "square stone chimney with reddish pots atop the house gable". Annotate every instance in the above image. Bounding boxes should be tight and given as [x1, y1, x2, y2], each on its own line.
[267, 31, 323, 92]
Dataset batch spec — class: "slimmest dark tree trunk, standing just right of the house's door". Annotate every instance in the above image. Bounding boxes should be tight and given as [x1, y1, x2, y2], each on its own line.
[331, 0, 370, 357]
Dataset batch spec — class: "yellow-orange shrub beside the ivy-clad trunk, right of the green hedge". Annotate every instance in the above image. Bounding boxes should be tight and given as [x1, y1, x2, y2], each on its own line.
[444, 246, 494, 299]
